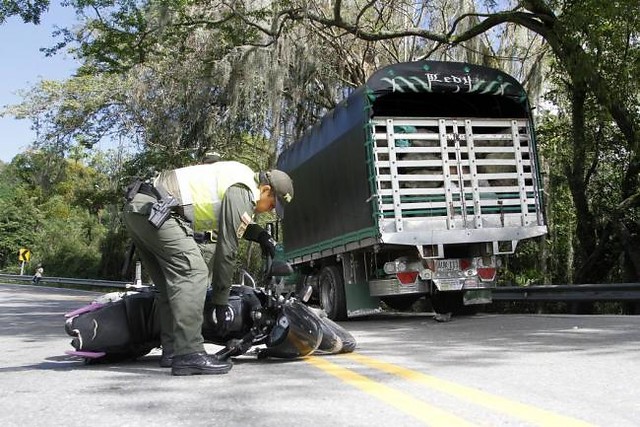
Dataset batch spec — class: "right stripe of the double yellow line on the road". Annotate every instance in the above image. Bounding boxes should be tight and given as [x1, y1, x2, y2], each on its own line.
[343, 353, 592, 427]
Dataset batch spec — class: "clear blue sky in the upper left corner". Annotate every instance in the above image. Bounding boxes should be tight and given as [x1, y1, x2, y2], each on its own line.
[0, 0, 78, 163]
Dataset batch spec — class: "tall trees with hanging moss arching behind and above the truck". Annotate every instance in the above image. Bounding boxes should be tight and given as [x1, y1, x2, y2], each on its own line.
[0, 0, 640, 288]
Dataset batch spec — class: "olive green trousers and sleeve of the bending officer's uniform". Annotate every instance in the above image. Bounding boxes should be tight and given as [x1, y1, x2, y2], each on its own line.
[124, 184, 254, 356]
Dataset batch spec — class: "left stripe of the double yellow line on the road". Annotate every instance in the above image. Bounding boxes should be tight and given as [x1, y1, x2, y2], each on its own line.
[304, 356, 475, 427]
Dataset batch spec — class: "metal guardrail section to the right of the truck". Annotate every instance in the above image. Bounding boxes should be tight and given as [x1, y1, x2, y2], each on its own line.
[492, 283, 640, 302]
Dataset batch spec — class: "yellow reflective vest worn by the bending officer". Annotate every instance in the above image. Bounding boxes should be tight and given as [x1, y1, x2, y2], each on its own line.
[154, 161, 260, 231]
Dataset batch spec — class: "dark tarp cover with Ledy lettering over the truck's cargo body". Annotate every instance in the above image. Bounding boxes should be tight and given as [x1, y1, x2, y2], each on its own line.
[278, 61, 529, 256]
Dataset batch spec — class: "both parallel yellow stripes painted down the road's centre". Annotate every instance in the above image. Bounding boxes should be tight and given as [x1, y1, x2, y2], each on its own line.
[305, 353, 591, 427]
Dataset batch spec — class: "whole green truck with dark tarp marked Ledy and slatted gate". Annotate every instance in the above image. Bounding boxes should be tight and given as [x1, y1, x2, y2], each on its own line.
[278, 60, 547, 319]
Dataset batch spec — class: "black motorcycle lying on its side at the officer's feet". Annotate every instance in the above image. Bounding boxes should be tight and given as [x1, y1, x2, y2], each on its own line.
[65, 258, 356, 363]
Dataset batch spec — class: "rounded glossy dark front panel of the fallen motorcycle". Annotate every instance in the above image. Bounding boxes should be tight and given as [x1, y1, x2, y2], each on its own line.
[266, 301, 322, 359]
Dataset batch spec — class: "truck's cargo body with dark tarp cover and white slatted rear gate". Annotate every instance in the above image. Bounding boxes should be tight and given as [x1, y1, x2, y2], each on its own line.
[278, 61, 546, 264]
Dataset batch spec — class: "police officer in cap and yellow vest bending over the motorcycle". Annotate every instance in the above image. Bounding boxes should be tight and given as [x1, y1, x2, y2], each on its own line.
[124, 161, 293, 375]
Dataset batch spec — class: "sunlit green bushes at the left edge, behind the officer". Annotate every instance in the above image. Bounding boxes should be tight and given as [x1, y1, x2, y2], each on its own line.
[0, 151, 124, 278]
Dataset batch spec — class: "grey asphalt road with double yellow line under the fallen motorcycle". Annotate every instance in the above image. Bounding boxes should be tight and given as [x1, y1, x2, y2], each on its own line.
[0, 284, 640, 427]
